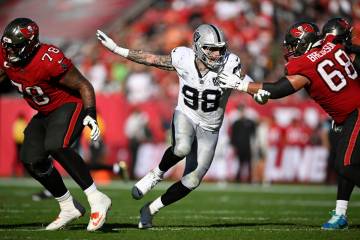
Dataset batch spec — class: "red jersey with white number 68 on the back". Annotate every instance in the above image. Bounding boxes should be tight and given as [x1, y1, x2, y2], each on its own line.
[285, 42, 360, 124]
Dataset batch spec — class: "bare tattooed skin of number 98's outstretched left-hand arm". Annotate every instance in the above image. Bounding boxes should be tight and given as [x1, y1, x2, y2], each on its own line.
[127, 50, 175, 71]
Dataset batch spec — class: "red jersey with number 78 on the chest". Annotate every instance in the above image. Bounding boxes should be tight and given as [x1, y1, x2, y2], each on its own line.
[0, 44, 81, 115]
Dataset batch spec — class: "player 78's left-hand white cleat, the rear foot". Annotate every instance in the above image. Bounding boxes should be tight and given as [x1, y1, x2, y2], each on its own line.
[45, 200, 85, 231]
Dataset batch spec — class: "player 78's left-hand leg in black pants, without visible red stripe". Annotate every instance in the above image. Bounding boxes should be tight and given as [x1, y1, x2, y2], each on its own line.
[21, 114, 85, 230]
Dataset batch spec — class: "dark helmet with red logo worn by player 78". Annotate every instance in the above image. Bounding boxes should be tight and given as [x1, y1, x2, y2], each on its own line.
[1, 18, 40, 64]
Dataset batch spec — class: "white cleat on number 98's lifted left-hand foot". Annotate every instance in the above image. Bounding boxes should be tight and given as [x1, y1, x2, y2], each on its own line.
[131, 170, 164, 200]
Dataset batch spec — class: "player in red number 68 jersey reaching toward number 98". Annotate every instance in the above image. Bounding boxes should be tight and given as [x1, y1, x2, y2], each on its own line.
[219, 22, 360, 229]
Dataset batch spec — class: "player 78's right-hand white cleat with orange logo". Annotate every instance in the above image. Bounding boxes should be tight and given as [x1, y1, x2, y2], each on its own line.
[87, 193, 111, 231]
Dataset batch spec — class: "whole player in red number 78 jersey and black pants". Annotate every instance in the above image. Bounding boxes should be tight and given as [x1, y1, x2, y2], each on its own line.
[0, 18, 111, 231]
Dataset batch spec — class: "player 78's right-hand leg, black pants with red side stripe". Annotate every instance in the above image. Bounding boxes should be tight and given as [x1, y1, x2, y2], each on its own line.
[45, 103, 111, 231]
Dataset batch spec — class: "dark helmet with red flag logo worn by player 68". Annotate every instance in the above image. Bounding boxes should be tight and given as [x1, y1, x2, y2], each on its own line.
[284, 22, 320, 59]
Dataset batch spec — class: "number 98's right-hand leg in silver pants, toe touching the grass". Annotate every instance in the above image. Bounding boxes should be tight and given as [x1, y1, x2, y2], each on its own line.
[139, 127, 218, 228]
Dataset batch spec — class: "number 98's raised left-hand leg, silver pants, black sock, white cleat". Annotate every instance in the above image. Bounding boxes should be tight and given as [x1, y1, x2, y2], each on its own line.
[132, 111, 195, 199]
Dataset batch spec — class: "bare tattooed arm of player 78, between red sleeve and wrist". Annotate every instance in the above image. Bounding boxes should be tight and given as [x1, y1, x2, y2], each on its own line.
[60, 67, 96, 109]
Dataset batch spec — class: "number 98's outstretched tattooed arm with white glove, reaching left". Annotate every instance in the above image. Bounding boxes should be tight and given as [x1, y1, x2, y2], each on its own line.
[96, 30, 175, 71]
